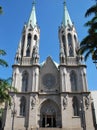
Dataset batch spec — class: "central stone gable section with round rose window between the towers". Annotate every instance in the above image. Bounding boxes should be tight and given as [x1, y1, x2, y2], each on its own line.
[40, 57, 59, 91]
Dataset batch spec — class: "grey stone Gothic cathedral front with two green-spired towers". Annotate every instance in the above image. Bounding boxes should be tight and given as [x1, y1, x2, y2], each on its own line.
[3, 2, 94, 130]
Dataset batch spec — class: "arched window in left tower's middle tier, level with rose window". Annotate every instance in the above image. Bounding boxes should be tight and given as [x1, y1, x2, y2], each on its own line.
[22, 71, 28, 92]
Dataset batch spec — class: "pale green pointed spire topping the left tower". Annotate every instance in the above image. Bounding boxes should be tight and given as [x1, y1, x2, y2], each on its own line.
[28, 0, 37, 27]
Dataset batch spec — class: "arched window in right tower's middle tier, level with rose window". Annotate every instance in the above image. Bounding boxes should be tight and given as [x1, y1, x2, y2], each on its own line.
[70, 70, 77, 91]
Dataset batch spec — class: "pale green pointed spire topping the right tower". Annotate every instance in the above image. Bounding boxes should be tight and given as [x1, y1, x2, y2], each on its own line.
[62, 0, 73, 26]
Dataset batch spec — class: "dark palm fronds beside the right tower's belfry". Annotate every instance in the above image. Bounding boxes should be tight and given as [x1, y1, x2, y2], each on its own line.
[79, 0, 97, 61]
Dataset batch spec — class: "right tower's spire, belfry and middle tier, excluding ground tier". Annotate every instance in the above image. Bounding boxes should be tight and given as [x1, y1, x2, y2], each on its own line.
[58, 1, 87, 92]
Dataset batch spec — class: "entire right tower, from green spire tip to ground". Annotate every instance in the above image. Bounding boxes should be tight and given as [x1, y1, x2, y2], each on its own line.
[58, 1, 93, 130]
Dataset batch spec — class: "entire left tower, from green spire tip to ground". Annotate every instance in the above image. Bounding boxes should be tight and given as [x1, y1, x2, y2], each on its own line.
[4, 1, 40, 130]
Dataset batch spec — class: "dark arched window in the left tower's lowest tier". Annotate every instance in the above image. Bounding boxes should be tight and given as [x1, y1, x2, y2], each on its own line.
[20, 96, 26, 116]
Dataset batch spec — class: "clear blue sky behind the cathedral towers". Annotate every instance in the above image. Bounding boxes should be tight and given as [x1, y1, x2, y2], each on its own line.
[0, 0, 97, 90]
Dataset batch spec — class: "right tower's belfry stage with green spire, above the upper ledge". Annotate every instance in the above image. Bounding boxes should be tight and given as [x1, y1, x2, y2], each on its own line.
[59, 2, 79, 64]
